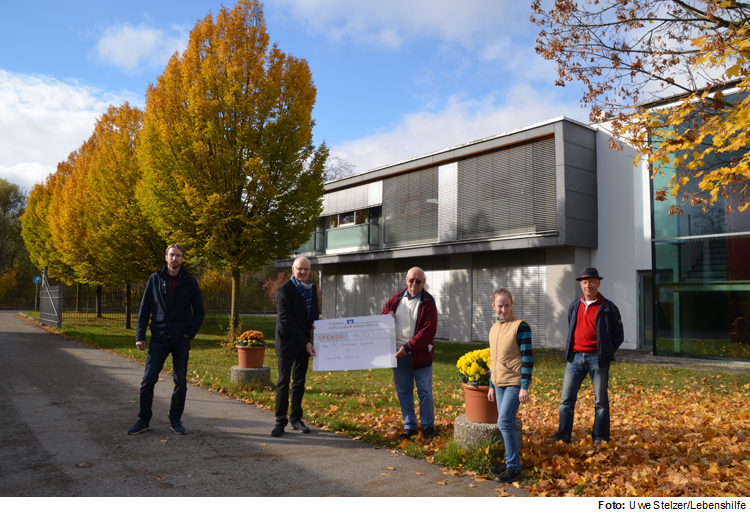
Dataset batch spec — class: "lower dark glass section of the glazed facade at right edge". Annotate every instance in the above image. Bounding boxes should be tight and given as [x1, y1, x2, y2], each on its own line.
[654, 236, 750, 359]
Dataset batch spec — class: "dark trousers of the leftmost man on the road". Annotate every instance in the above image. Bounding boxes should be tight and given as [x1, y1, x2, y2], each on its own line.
[138, 337, 190, 423]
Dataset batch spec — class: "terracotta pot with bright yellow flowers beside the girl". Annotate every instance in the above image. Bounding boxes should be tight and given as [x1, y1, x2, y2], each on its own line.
[456, 348, 497, 423]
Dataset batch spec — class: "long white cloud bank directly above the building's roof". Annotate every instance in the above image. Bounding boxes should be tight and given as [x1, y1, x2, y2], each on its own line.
[331, 85, 588, 172]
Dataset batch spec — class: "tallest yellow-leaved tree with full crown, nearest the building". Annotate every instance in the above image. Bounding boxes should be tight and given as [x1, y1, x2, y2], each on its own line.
[138, 0, 328, 333]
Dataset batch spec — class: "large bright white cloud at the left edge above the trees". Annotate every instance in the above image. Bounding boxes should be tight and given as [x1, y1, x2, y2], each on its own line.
[0, 69, 135, 189]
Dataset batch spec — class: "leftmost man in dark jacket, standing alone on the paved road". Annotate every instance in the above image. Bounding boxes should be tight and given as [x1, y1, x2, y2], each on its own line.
[128, 244, 206, 434]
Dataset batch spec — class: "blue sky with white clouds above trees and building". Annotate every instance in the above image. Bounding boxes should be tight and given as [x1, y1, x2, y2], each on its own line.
[0, 0, 587, 189]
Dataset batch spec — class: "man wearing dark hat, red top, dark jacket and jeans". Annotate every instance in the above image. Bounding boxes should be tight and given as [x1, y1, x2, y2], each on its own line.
[553, 268, 625, 445]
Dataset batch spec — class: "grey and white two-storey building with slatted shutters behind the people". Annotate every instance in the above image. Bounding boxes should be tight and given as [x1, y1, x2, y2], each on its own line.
[284, 118, 652, 348]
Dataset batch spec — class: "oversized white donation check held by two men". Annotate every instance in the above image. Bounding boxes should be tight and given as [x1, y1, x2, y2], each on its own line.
[313, 315, 396, 371]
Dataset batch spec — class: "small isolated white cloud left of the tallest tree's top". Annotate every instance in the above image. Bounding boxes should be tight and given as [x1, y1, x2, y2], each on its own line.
[96, 24, 189, 74]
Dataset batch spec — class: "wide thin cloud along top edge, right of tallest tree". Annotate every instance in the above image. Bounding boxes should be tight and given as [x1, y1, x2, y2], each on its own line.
[274, 0, 533, 49]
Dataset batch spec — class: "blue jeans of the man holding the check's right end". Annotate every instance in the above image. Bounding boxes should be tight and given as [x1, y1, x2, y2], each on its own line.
[393, 354, 435, 430]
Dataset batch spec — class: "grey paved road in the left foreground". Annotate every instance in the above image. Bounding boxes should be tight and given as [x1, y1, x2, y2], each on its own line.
[0, 312, 527, 496]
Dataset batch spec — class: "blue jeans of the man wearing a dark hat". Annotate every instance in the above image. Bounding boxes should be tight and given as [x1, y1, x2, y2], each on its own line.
[555, 352, 609, 443]
